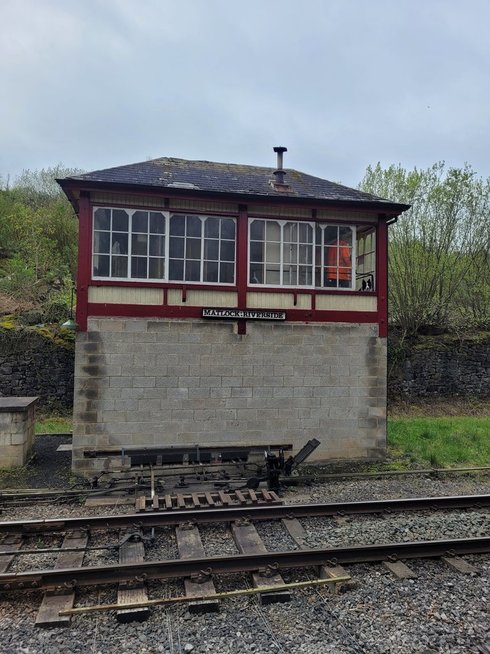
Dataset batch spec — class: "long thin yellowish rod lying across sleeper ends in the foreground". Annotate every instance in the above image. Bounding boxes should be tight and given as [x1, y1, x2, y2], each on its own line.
[58, 576, 352, 615]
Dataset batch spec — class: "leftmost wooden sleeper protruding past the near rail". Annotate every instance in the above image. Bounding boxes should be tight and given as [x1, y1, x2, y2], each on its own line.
[35, 531, 88, 627]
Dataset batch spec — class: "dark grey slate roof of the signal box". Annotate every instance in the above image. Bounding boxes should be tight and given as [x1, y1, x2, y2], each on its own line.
[58, 157, 408, 211]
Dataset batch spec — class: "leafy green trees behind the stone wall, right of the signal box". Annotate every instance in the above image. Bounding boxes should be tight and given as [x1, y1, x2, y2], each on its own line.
[360, 162, 490, 334]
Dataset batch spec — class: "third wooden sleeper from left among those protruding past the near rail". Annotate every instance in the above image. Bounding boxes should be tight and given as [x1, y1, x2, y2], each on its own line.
[175, 526, 219, 613]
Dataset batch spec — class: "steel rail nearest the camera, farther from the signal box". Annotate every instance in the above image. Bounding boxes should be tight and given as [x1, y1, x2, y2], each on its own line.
[0, 537, 490, 591]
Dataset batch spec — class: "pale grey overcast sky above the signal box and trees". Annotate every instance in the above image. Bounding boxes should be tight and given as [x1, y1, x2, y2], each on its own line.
[0, 0, 490, 186]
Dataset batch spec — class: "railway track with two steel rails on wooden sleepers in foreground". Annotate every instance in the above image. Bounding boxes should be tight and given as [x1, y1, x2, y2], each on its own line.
[0, 495, 490, 626]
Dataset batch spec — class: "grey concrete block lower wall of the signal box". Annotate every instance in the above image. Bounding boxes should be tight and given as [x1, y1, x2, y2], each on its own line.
[73, 318, 386, 475]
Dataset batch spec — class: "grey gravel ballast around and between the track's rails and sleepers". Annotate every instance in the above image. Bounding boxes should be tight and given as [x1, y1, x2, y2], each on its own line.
[0, 444, 490, 654]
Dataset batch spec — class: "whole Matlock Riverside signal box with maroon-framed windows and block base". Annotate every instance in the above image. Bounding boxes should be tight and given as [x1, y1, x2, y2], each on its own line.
[59, 148, 408, 475]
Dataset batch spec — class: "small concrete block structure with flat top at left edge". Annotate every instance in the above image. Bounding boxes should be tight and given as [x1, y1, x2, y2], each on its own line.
[0, 397, 39, 468]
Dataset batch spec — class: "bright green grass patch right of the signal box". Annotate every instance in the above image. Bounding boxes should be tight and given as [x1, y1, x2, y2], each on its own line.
[388, 416, 490, 468]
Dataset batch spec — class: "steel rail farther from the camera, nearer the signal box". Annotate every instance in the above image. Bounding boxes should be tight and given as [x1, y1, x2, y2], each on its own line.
[0, 495, 490, 535]
